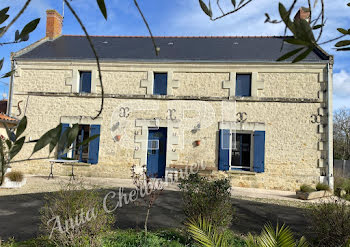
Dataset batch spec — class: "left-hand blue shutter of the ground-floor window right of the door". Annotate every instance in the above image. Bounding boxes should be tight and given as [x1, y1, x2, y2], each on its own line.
[219, 130, 231, 171]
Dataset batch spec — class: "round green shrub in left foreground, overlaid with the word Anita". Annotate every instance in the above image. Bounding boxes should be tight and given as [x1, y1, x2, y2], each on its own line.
[40, 183, 114, 247]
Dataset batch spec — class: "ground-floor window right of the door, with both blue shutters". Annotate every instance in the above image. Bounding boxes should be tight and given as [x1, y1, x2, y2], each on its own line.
[218, 129, 265, 173]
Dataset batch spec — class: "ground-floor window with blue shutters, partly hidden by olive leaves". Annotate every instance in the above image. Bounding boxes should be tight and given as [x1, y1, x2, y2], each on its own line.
[57, 123, 101, 164]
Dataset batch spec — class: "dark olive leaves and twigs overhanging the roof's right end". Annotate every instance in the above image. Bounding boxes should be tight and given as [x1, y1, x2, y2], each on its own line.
[198, 0, 350, 63]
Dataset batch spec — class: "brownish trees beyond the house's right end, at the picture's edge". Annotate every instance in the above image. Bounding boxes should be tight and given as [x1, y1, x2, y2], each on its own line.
[333, 108, 350, 160]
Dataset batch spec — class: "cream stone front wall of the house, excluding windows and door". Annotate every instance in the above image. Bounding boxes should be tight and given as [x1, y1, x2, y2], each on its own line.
[7, 60, 331, 190]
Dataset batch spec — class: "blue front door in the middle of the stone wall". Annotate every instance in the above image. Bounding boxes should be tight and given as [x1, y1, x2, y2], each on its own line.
[147, 128, 167, 178]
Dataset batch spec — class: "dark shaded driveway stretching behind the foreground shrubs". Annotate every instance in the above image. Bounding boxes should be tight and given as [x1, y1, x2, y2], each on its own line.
[0, 189, 308, 241]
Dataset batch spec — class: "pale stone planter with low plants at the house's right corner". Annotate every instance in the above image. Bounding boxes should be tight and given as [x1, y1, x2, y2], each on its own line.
[296, 183, 332, 200]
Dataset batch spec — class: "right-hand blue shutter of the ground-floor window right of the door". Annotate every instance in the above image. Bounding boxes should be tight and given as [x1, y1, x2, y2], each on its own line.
[254, 131, 265, 172]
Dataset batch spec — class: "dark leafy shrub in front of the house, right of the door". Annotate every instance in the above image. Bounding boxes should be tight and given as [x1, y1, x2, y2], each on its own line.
[179, 174, 234, 228]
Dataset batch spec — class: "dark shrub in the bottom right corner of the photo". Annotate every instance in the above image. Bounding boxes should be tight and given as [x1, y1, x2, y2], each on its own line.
[311, 201, 350, 247]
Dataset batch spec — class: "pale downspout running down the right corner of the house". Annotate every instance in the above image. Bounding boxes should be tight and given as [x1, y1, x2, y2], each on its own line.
[327, 56, 334, 190]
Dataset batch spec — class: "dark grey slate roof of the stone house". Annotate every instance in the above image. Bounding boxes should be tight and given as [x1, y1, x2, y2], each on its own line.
[16, 35, 329, 63]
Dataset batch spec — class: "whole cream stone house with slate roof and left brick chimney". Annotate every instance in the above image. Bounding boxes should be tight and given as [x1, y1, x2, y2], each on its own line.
[8, 10, 333, 190]
